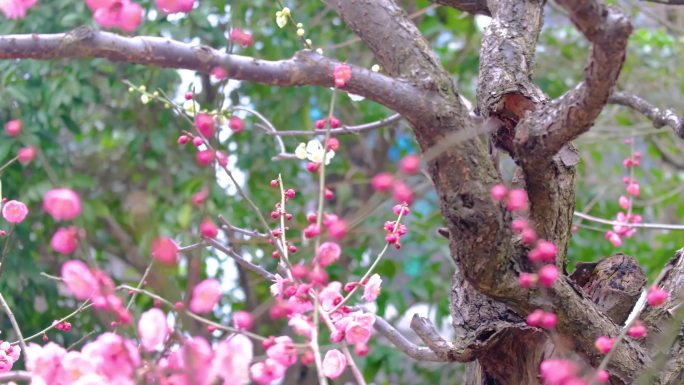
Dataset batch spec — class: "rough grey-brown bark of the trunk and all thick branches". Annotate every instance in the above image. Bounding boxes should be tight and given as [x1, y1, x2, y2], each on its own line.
[0, 0, 684, 385]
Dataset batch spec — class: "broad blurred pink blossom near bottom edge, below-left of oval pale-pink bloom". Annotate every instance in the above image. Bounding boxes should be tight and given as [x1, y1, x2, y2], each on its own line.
[81, 333, 140, 384]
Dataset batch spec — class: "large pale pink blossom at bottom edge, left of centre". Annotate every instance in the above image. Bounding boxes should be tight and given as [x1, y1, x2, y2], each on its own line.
[213, 334, 254, 385]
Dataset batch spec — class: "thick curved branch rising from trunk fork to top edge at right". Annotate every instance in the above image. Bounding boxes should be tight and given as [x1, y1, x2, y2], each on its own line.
[516, 0, 632, 154]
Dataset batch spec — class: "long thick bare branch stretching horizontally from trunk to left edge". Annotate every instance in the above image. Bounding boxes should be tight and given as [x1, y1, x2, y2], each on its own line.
[0, 27, 421, 115]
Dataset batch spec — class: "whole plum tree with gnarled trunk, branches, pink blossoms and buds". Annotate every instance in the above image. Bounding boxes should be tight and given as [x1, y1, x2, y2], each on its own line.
[0, 0, 684, 385]
